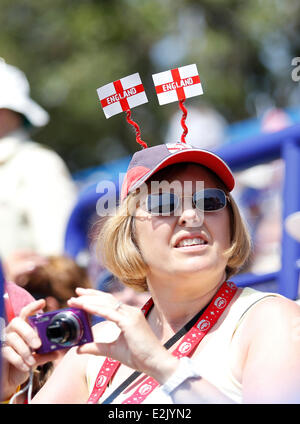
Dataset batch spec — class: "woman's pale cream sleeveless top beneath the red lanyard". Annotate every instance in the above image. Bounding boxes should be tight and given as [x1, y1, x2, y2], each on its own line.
[86, 287, 280, 404]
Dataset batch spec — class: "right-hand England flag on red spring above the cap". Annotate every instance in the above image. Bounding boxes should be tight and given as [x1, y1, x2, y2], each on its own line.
[152, 64, 203, 105]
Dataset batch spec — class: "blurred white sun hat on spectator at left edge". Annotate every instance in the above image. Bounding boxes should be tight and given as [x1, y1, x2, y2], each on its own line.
[0, 58, 49, 127]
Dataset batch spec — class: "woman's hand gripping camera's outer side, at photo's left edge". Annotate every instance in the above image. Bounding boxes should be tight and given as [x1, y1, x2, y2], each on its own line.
[2, 299, 57, 400]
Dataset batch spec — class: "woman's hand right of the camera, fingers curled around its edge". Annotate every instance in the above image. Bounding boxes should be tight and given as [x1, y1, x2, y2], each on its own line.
[68, 288, 178, 383]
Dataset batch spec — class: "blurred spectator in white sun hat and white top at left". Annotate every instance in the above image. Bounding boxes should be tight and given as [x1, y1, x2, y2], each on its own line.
[0, 58, 77, 260]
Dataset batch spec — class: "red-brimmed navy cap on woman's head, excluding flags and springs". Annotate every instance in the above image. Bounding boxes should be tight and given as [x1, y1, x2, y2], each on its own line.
[121, 143, 234, 200]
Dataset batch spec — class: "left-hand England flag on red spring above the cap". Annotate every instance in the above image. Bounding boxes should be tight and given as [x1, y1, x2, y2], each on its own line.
[97, 73, 148, 118]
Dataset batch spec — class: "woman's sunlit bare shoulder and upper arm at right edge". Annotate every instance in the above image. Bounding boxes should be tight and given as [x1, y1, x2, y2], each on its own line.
[238, 296, 300, 403]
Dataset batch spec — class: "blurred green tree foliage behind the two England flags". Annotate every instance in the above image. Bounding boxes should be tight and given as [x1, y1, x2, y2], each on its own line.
[0, 0, 300, 171]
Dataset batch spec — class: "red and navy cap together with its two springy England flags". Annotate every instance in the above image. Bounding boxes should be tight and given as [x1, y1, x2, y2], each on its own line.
[97, 64, 234, 200]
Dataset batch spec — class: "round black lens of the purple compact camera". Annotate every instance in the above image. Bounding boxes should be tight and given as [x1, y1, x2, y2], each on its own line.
[46, 312, 81, 347]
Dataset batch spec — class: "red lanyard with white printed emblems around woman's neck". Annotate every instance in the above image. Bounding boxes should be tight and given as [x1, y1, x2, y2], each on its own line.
[87, 282, 237, 404]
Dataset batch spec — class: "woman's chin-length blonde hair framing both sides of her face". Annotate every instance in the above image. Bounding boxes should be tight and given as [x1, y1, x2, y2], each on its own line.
[98, 193, 251, 291]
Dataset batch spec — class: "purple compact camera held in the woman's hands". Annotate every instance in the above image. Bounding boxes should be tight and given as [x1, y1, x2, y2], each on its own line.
[28, 308, 93, 353]
